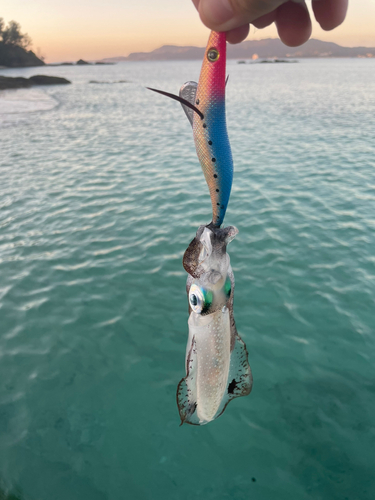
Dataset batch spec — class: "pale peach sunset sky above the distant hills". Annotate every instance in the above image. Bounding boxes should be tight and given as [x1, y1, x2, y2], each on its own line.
[0, 0, 375, 62]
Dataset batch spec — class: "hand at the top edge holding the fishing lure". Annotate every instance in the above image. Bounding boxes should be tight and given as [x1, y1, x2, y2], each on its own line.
[193, 0, 348, 47]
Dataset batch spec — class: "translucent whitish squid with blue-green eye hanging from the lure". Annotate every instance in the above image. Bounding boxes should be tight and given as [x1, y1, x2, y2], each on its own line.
[177, 225, 252, 425]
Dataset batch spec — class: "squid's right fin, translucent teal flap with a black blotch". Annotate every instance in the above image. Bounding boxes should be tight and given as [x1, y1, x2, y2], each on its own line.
[215, 334, 253, 418]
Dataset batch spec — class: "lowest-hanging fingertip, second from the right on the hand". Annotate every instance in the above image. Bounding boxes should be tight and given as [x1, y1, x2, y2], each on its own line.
[275, 2, 312, 47]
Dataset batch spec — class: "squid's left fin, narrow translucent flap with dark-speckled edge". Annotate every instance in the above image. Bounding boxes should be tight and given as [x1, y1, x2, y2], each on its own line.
[177, 337, 199, 425]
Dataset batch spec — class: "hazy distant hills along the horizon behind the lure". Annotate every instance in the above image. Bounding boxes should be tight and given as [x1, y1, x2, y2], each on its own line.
[103, 38, 375, 62]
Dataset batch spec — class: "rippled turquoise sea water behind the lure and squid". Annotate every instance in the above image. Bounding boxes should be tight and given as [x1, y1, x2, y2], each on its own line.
[0, 59, 375, 500]
